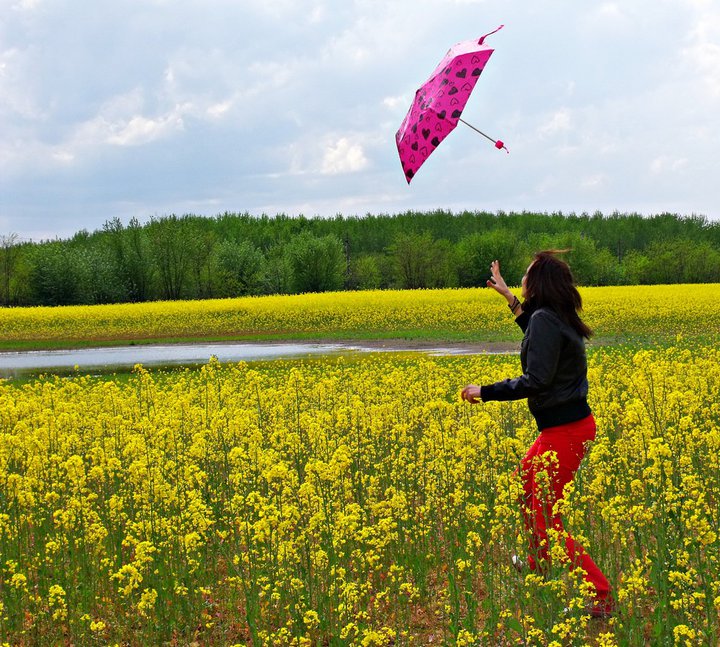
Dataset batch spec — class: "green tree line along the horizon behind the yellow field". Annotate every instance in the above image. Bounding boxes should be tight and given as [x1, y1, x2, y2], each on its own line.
[0, 210, 720, 305]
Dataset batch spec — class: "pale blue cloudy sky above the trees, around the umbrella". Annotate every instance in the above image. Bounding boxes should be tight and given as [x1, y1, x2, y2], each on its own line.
[0, 0, 720, 241]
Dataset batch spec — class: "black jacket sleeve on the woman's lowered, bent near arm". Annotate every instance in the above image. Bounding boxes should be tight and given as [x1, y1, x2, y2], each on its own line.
[480, 311, 563, 402]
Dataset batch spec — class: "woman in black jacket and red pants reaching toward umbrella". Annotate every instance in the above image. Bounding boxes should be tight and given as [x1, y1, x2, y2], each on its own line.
[462, 251, 613, 617]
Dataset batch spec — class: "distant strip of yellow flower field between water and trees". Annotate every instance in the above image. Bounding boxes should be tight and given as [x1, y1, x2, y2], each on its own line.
[0, 284, 720, 348]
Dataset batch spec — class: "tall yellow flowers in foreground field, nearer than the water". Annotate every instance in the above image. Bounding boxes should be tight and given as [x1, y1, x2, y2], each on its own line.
[0, 342, 720, 647]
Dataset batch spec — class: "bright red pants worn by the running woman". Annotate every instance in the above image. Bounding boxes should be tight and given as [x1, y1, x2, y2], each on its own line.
[520, 415, 610, 600]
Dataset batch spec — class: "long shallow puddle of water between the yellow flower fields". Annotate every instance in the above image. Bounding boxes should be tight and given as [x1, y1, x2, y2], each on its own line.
[0, 343, 512, 377]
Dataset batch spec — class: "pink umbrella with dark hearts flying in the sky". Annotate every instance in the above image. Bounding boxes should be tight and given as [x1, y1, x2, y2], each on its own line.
[395, 25, 509, 184]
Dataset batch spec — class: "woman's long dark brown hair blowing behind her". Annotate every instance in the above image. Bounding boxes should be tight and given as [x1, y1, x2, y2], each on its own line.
[525, 249, 592, 339]
